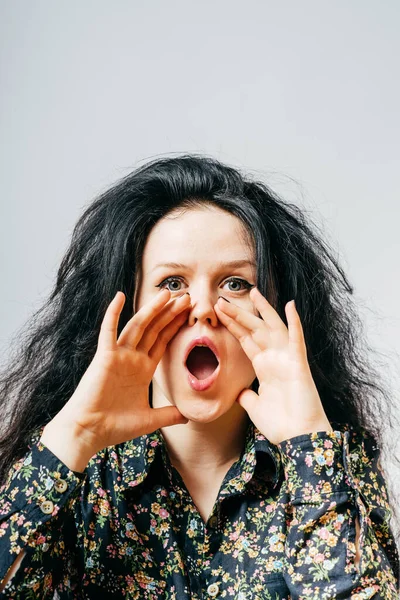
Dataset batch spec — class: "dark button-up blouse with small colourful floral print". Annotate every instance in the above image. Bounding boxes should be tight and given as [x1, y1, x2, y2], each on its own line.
[0, 421, 399, 600]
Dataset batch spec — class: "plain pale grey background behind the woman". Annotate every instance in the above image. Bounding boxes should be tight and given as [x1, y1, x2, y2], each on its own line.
[0, 0, 400, 508]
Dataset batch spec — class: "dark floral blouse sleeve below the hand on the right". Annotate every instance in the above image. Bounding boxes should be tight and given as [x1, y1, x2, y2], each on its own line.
[277, 427, 399, 600]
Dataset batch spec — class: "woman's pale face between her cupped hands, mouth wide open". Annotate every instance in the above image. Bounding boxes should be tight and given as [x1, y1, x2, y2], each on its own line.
[135, 206, 258, 423]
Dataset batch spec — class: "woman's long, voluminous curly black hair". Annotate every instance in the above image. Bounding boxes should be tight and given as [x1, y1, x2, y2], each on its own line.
[0, 154, 400, 548]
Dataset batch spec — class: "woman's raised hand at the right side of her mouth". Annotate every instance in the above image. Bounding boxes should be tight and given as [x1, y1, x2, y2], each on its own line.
[215, 288, 332, 444]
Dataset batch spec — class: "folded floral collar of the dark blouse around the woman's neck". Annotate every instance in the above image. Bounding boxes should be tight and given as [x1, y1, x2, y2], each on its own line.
[108, 419, 282, 496]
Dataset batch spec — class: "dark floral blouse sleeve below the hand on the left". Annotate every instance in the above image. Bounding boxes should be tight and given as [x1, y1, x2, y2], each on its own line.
[0, 428, 86, 598]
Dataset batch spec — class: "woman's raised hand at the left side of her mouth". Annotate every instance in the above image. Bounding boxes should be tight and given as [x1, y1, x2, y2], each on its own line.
[41, 289, 190, 470]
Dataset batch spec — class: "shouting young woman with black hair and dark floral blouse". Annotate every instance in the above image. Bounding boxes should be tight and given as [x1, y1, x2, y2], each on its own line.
[0, 155, 399, 600]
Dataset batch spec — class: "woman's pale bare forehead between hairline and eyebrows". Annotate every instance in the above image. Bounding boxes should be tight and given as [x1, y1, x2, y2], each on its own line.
[143, 206, 254, 270]
